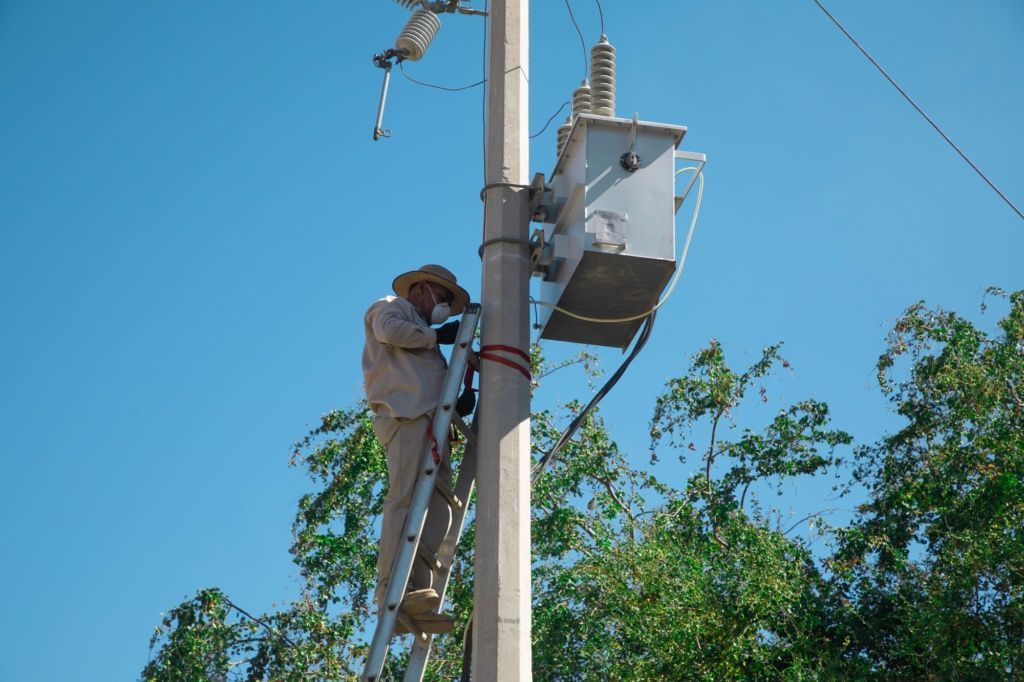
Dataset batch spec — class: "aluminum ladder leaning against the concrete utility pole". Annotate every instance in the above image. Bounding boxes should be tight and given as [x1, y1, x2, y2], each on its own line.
[359, 303, 480, 682]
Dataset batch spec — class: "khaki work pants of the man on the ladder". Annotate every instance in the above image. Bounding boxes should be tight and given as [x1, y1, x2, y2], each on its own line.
[374, 416, 452, 604]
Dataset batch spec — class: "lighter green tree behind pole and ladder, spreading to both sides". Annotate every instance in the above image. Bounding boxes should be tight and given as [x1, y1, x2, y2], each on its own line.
[143, 343, 849, 681]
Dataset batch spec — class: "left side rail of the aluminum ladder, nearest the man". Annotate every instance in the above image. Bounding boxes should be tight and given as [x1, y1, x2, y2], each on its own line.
[360, 303, 480, 682]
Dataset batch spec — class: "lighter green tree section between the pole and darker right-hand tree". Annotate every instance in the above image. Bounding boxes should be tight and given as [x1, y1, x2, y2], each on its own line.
[534, 342, 850, 680]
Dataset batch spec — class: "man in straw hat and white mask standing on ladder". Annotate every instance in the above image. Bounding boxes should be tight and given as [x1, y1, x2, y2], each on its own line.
[362, 265, 476, 634]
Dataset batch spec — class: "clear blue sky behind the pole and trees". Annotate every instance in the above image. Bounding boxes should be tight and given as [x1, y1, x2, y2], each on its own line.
[0, 0, 1024, 682]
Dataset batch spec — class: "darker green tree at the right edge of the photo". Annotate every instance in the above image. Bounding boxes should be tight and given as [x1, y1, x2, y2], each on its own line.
[831, 290, 1024, 680]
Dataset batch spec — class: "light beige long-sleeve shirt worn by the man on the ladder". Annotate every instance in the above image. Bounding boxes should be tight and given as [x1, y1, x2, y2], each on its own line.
[362, 296, 447, 419]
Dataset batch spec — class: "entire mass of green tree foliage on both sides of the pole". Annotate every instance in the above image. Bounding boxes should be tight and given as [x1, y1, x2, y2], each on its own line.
[142, 292, 1024, 682]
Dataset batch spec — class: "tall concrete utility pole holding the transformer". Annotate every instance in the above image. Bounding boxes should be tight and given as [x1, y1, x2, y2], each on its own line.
[473, 0, 532, 682]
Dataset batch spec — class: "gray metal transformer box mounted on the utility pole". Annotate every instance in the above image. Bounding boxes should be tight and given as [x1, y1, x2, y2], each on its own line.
[539, 114, 686, 348]
